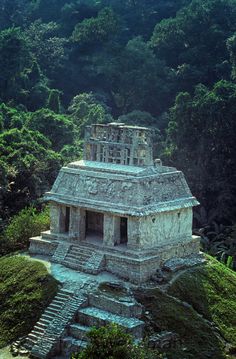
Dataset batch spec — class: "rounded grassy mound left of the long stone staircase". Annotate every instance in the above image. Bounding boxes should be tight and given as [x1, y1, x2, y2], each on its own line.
[0, 256, 57, 348]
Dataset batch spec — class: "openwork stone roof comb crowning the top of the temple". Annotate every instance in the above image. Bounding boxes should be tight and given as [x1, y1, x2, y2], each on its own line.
[83, 123, 153, 166]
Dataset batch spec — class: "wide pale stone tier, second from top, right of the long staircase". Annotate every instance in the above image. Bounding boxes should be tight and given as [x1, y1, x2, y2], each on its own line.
[77, 307, 144, 338]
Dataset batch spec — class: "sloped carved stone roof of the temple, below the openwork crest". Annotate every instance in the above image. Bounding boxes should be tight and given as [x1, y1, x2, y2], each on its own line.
[45, 161, 198, 216]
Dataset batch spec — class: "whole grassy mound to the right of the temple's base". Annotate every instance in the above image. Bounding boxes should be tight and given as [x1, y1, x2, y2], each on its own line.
[137, 258, 236, 359]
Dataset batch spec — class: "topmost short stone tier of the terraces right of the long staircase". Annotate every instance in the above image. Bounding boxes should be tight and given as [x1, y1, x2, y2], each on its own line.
[89, 292, 142, 318]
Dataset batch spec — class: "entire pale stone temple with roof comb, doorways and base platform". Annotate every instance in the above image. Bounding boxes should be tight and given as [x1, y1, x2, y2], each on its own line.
[30, 123, 199, 284]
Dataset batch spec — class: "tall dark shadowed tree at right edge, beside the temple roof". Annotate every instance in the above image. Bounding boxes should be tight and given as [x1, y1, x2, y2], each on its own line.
[165, 81, 236, 219]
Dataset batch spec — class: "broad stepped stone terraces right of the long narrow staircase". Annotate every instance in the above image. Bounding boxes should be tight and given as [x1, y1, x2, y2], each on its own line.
[61, 291, 144, 358]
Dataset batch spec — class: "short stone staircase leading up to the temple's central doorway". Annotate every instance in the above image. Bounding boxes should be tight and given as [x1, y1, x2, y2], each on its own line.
[61, 245, 105, 274]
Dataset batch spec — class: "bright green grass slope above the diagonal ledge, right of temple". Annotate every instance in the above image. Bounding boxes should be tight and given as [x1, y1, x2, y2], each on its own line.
[169, 256, 236, 347]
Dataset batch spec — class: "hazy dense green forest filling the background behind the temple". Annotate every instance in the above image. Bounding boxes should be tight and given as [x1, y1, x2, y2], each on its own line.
[0, 0, 236, 269]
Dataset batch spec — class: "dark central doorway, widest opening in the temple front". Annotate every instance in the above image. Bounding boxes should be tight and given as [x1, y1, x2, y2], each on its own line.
[86, 211, 104, 238]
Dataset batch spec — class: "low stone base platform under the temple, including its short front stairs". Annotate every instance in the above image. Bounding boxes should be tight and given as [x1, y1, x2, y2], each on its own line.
[29, 233, 199, 284]
